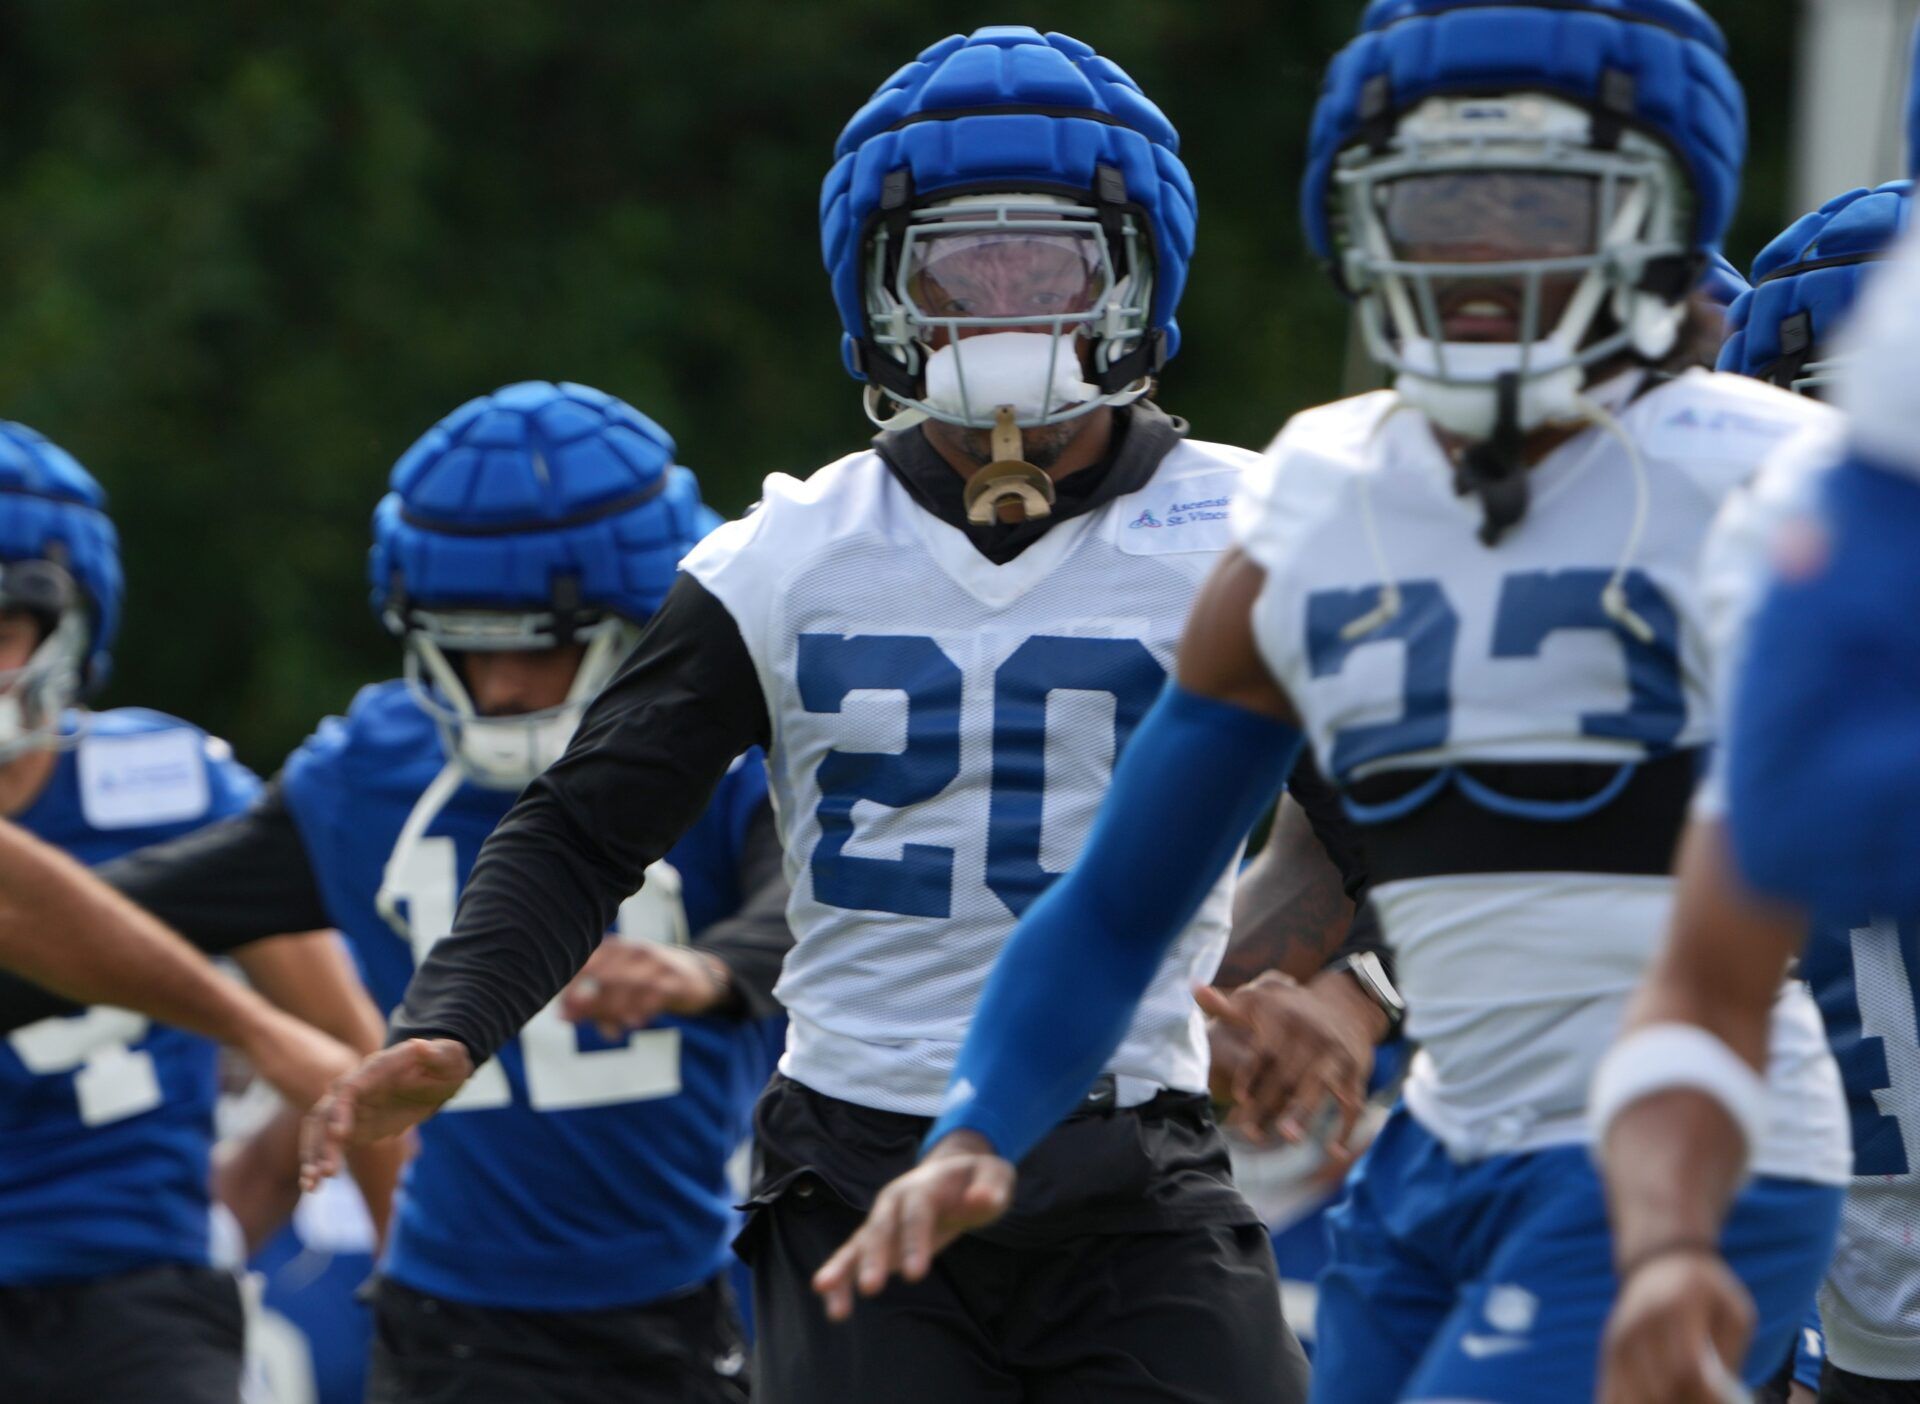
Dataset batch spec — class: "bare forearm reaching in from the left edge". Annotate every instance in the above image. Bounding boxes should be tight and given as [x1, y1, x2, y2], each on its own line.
[0, 824, 280, 1047]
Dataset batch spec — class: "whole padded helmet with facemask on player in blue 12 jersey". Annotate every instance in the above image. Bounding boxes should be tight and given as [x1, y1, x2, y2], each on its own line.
[369, 380, 714, 789]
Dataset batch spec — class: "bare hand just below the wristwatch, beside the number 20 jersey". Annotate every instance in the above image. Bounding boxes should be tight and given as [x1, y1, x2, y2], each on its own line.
[1194, 970, 1373, 1152]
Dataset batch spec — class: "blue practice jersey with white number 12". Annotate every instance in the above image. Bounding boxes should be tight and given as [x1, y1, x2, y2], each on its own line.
[284, 682, 770, 1310]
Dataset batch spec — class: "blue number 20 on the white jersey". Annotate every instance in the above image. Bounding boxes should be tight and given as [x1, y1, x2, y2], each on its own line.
[795, 634, 1165, 918]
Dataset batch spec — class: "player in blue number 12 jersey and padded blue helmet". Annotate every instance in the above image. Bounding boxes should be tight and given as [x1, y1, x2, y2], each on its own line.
[0, 382, 791, 1404]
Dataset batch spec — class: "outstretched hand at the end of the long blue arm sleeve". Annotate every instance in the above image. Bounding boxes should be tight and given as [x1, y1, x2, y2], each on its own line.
[814, 1131, 1014, 1321]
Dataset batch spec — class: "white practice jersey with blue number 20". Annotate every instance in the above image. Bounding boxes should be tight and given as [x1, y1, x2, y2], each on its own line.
[685, 442, 1258, 1116]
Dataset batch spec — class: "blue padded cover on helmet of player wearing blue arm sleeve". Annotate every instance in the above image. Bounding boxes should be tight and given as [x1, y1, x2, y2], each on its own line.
[1302, 0, 1747, 257]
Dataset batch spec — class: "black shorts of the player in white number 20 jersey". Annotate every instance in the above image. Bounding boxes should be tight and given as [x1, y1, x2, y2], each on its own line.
[737, 1077, 1308, 1404]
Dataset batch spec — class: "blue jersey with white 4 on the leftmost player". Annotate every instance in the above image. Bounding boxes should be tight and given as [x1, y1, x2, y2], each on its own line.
[0, 709, 259, 1285]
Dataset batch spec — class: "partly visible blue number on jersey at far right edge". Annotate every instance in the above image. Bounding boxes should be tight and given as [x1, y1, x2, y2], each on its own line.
[1801, 922, 1920, 1175]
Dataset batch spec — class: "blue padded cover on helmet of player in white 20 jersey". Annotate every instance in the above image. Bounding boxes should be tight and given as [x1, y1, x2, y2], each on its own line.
[820, 25, 1198, 378]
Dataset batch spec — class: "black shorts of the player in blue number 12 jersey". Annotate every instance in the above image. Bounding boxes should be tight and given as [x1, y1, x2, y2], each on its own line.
[367, 1277, 747, 1404]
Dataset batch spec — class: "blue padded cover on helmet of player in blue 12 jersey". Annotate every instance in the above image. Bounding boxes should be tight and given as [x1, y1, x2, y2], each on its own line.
[369, 380, 710, 622]
